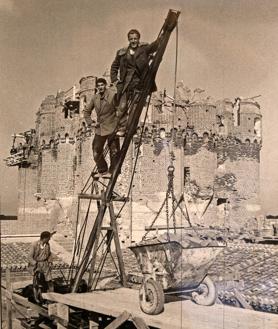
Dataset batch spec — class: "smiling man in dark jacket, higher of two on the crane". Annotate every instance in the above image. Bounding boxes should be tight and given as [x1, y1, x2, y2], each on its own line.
[110, 29, 159, 137]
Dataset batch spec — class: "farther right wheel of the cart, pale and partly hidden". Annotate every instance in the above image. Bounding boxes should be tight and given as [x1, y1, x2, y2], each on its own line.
[192, 276, 217, 306]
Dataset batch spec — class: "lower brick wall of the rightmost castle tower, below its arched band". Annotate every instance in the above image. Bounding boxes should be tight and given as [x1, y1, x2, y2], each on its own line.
[215, 143, 260, 228]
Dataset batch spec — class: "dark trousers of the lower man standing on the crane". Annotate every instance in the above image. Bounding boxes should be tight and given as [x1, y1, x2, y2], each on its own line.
[93, 134, 120, 173]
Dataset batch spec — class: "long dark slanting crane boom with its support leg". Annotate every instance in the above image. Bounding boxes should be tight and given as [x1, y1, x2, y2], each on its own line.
[72, 10, 180, 292]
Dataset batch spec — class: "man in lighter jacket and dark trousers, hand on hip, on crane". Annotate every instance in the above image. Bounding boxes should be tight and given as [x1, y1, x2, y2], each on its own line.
[84, 78, 120, 178]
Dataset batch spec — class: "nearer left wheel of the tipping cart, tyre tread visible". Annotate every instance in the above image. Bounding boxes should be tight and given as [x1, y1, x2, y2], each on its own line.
[139, 279, 164, 315]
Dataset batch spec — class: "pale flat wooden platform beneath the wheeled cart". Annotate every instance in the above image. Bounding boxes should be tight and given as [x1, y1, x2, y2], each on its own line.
[44, 288, 278, 329]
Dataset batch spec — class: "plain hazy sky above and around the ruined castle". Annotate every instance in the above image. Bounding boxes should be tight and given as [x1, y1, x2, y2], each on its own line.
[0, 0, 278, 214]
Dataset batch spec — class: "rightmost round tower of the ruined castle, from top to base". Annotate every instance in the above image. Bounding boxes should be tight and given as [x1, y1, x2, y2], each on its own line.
[215, 101, 262, 229]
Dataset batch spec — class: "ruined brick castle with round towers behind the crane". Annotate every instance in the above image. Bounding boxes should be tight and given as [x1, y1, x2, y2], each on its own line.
[2, 76, 262, 243]
